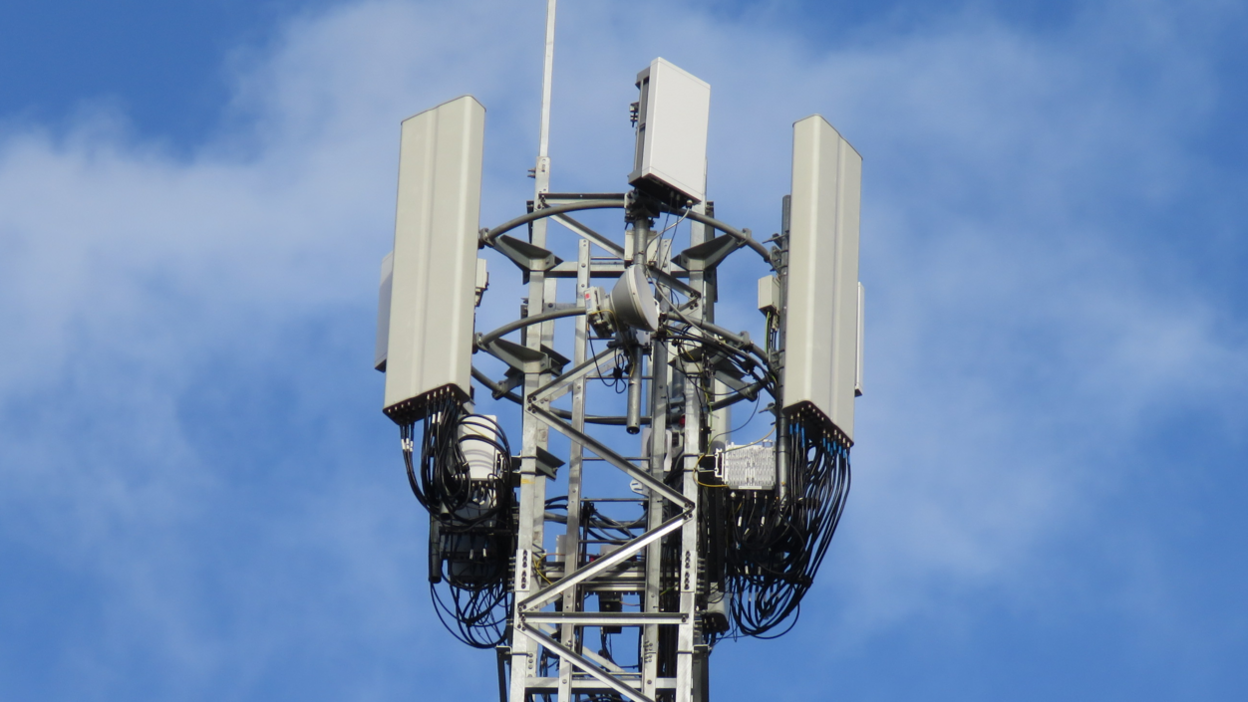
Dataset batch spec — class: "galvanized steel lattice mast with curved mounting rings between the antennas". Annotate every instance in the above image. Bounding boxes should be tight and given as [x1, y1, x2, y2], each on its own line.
[474, 186, 770, 702]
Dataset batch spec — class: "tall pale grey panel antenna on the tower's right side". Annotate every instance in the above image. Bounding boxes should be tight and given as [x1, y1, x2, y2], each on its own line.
[784, 115, 862, 442]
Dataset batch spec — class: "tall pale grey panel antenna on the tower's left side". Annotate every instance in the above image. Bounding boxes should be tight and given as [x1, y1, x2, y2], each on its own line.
[383, 95, 485, 423]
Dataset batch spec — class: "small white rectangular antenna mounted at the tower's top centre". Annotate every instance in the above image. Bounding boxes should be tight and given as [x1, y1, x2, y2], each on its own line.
[628, 59, 710, 204]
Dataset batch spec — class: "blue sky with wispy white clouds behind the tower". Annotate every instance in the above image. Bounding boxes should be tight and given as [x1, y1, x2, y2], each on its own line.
[0, 0, 1248, 701]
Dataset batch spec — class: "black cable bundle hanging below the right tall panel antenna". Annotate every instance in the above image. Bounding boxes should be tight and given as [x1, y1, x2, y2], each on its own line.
[725, 413, 850, 638]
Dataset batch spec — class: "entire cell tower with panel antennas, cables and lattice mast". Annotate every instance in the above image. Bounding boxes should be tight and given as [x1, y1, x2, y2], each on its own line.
[377, 0, 862, 702]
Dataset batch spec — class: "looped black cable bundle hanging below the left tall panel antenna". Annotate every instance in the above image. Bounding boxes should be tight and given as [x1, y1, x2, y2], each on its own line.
[401, 396, 517, 648]
